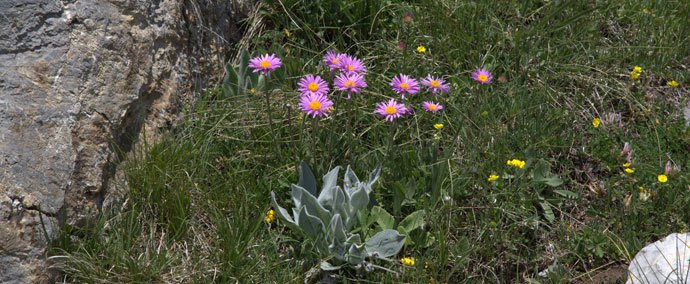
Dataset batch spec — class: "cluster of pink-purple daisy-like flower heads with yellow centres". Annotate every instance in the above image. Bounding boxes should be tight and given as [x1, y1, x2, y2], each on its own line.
[249, 50, 493, 122]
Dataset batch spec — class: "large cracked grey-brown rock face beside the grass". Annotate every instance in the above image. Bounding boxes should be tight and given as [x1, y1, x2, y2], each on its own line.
[0, 0, 253, 283]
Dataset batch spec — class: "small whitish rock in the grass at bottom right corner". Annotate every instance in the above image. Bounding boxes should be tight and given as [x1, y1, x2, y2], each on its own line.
[626, 233, 690, 284]
